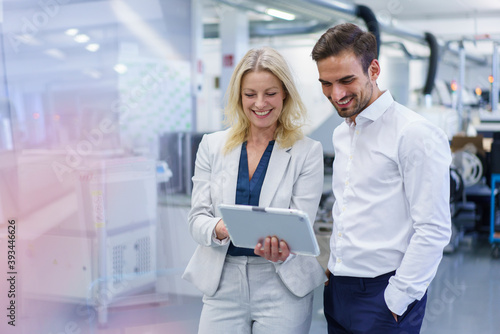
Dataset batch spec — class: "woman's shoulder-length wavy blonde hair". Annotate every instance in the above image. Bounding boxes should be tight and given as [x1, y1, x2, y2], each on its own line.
[224, 47, 307, 153]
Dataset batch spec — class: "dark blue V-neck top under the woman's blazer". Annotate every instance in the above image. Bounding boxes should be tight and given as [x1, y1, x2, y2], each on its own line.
[227, 140, 274, 256]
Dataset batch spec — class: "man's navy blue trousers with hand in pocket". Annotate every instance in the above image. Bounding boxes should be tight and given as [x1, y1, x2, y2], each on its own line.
[323, 272, 427, 334]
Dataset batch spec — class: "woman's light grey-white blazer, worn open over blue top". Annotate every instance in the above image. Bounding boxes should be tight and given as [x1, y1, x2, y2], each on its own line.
[183, 130, 326, 297]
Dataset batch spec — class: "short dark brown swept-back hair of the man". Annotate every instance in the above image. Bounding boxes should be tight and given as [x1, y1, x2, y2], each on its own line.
[311, 23, 377, 73]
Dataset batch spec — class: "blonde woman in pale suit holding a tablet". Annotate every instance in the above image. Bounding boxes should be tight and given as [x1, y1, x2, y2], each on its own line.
[183, 47, 326, 334]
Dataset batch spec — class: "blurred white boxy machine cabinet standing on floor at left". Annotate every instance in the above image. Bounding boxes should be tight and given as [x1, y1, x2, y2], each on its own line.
[23, 156, 161, 324]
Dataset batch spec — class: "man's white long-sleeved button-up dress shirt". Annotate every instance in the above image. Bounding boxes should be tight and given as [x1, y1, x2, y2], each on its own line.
[328, 91, 451, 315]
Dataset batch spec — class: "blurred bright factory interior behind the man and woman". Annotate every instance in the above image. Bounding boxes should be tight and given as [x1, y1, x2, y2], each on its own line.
[0, 0, 500, 334]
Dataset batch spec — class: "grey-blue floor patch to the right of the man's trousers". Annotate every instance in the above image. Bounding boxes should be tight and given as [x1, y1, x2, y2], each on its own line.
[422, 237, 500, 334]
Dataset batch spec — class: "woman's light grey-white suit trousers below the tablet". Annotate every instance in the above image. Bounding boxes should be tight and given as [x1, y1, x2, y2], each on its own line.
[198, 255, 313, 334]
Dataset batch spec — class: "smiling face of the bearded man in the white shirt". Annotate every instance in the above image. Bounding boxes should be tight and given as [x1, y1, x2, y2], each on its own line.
[317, 51, 380, 121]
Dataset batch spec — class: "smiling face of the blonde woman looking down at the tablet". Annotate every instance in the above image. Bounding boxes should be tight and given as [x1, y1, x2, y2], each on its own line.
[241, 71, 286, 133]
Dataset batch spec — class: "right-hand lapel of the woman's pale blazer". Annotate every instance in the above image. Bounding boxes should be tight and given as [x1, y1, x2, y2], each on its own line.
[259, 143, 291, 207]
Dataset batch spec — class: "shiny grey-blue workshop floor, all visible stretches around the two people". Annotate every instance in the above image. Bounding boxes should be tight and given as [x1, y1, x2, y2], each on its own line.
[9, 237, 500, 334]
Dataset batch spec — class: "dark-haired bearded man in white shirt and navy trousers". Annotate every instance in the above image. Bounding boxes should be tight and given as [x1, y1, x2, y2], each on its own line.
[312, 23, 451, 334]
